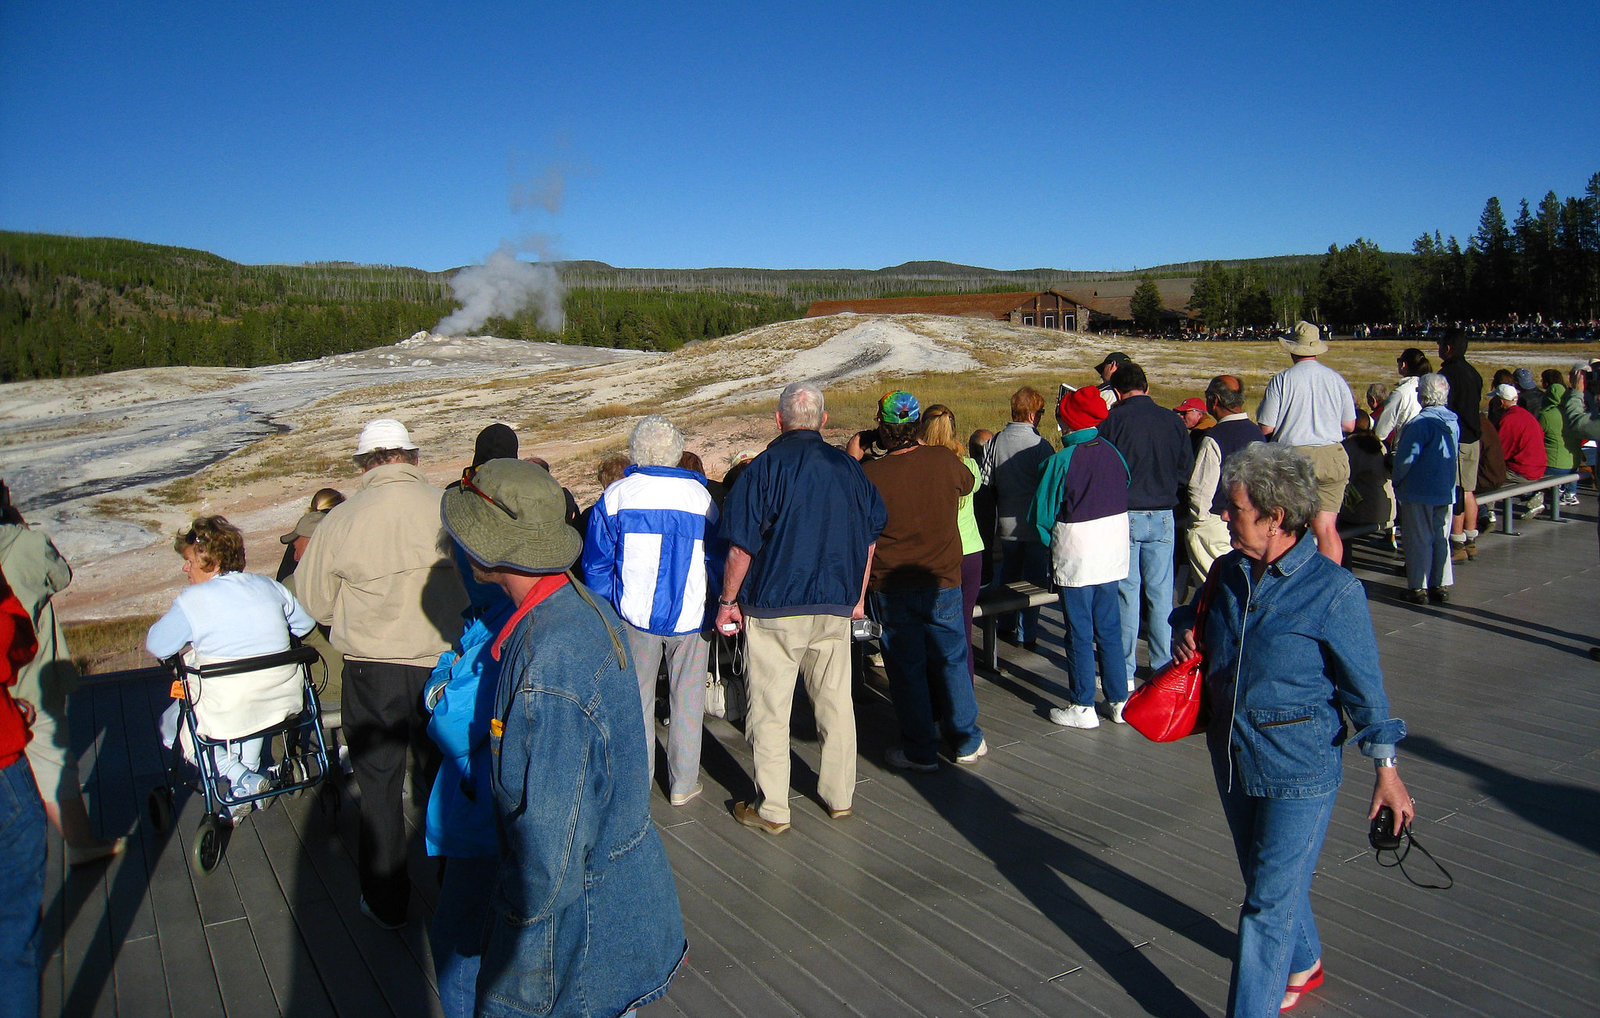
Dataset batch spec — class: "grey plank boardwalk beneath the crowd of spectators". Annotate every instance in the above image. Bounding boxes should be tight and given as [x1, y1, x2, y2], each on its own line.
[45, 505, 1600, 1018]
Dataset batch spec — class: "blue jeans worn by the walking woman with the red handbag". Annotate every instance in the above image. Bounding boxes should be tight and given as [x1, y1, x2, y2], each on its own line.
[1211, 752, 1339, 1018]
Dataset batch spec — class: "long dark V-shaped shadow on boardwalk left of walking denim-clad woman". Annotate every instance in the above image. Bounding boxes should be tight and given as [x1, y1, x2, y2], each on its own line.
[909, 755, 1235, 1018]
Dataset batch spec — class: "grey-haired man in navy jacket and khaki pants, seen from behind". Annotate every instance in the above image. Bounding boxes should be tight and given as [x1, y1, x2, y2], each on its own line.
[717, 383, 886, 834]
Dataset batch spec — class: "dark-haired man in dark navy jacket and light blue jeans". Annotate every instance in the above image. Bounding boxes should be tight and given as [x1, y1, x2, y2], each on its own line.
[1099, 362, 1195, 677]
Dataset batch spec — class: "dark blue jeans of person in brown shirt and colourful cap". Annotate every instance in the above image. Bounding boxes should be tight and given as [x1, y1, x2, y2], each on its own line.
[872, 587, 984, 764]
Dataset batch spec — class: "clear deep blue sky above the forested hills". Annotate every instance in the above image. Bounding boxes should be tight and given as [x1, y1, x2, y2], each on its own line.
[0, 0, 1600, 269]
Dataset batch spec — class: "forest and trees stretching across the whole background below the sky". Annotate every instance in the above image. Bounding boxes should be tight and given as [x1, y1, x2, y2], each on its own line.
[0, 173, 1600, 381]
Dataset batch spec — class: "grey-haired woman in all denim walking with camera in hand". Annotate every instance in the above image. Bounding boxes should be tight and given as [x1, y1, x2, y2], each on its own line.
[1174, 442, 1414, 1018]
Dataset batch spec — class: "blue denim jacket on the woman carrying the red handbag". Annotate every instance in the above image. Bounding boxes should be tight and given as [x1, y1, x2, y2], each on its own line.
[1174, 533, 1405, 799]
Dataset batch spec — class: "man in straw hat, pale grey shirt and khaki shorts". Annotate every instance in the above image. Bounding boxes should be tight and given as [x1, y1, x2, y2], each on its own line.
[1256, 322, 1355, 563]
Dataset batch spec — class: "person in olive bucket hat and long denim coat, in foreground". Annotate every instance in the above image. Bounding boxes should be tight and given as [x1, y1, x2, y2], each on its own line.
[440, 459, 688, 1016]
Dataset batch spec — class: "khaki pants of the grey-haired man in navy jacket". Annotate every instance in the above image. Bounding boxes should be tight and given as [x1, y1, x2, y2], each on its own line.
[744, 615, 856, 824]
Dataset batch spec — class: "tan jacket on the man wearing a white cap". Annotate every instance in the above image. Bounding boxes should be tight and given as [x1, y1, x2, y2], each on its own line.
[294, 463, 467, 667]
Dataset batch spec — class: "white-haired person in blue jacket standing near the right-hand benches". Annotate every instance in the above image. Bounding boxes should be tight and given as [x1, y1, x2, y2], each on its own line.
[1394, 373, 1461, 605]
